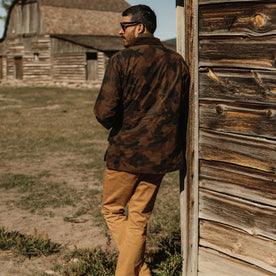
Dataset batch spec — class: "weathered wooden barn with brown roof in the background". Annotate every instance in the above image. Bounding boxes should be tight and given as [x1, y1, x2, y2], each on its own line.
[0, 0, 129, 84]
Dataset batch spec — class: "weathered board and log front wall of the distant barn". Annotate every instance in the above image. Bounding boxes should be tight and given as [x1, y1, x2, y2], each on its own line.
[1, 0, 107, 83]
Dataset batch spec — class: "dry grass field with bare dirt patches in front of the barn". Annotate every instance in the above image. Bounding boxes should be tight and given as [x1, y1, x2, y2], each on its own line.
[0, 87, 181, 276]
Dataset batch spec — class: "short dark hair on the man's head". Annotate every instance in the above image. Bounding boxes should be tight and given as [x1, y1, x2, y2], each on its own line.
[122, 5, 156, 34]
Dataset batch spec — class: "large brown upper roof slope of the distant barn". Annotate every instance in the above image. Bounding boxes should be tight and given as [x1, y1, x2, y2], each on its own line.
[37, 0, 129, 36]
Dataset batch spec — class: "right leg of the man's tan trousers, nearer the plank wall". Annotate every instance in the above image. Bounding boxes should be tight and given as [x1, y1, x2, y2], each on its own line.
[112, 171, 163, 276]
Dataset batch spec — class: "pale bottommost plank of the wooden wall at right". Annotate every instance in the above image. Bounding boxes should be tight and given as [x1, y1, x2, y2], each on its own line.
[198, 247, 275, 276]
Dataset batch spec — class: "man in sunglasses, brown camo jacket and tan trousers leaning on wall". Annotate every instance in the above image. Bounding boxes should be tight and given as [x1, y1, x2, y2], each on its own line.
[94, 5, 189, 276]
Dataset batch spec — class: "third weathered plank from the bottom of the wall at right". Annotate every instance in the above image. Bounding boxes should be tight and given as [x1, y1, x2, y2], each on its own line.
[199, 189, 276, 242]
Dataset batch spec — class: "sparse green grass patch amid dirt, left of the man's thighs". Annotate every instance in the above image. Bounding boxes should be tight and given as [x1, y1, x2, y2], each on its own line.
[0, 172, 101, 219]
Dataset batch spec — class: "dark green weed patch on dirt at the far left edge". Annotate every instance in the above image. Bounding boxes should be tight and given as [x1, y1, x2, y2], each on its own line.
[0, 227, 61, 258]
